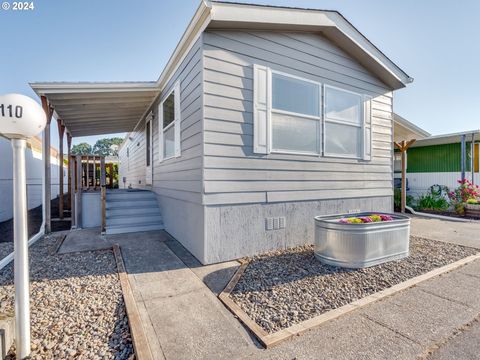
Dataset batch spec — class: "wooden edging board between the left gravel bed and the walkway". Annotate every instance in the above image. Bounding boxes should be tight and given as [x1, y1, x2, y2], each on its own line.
[112, 244, 153, 360]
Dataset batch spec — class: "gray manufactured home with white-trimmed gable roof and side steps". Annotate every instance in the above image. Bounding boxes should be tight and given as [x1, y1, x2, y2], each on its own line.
[32, 1, 413, 264]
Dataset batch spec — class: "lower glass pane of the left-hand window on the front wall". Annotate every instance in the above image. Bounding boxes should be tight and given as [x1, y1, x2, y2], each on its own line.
[272, 113, 320, 153]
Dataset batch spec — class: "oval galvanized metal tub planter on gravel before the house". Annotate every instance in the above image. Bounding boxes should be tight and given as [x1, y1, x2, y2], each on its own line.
[315, 213, 410, 269]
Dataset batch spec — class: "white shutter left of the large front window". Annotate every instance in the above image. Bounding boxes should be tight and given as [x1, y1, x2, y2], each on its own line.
[253, 64, 269, 154]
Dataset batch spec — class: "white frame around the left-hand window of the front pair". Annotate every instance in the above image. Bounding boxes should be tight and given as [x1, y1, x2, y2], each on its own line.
[267, 70, 323, 157]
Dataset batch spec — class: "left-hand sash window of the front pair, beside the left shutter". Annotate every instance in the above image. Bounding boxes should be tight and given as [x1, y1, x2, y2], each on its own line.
[271, 72, 321, 155]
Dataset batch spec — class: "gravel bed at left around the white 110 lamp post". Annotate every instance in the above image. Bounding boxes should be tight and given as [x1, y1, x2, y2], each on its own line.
[0, 236, 134, 359]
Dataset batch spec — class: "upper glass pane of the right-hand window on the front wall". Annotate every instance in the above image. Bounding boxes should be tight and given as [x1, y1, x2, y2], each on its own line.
[325, 87, 362, 124]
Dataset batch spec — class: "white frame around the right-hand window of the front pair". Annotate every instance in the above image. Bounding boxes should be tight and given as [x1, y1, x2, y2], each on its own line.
[322, 84, 365, 160]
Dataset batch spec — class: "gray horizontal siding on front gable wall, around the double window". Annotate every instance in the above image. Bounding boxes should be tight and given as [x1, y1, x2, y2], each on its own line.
[203, 30, 393, 205]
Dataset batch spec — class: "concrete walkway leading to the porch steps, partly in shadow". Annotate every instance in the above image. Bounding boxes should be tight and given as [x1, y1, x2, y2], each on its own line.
[107, 232, 256, 360]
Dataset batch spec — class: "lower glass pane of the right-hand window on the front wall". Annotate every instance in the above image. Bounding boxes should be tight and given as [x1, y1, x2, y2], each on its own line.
[325, 122, 362, 157]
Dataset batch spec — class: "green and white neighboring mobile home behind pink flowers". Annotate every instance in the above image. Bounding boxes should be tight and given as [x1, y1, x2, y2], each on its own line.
[395, 130, 480, 196]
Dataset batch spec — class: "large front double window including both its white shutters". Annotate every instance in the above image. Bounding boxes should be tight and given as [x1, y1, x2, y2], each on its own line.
[253, 65, 372, 160]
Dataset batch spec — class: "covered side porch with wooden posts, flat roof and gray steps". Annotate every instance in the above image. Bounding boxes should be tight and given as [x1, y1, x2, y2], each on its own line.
[30, 82, 163, 233]
